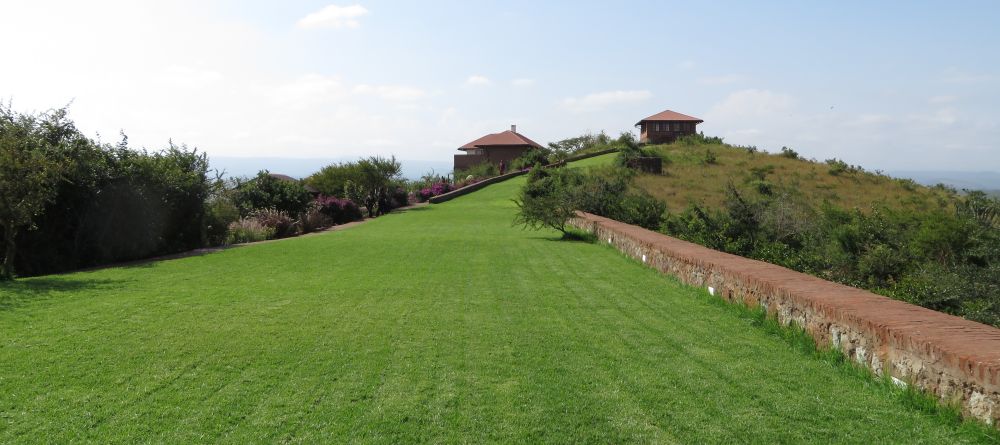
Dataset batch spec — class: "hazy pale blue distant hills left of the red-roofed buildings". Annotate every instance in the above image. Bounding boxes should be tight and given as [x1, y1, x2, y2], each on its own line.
[208, 156, 452, 179]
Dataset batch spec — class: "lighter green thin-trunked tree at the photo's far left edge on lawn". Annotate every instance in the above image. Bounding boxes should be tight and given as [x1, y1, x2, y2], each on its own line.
[0, 104, 71, 281]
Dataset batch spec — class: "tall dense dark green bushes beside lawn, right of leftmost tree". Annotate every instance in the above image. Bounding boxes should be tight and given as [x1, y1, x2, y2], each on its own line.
[0, 108, 213, 275]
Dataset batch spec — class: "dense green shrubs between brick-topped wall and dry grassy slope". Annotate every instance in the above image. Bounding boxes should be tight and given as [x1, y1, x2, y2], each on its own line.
[665, 179, 1000, 326]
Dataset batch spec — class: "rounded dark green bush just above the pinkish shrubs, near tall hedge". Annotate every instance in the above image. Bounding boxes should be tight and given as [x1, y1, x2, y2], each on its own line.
[231, 170, 313, 217]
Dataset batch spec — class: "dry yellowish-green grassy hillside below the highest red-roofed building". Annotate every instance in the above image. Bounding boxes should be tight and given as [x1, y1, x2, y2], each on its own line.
[636, 143, 953, 212]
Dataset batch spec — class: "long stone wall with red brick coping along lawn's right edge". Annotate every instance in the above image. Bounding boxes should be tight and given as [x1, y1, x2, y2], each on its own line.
[571, 212, 1000, 424]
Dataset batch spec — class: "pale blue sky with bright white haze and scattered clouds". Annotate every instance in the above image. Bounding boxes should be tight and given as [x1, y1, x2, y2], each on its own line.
[0, 0, 1000, 171]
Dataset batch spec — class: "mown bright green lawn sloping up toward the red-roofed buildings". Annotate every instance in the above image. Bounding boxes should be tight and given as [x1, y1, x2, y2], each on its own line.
[0, 164, 988, 444]
